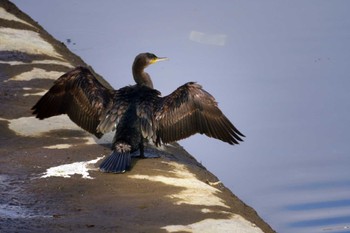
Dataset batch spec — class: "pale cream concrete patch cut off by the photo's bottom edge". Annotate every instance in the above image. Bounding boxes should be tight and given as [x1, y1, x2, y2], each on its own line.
[162, 215, 263, 233]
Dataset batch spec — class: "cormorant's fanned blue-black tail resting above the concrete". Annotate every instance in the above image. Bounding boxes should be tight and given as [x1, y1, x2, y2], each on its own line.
[100, 150, 131, 173]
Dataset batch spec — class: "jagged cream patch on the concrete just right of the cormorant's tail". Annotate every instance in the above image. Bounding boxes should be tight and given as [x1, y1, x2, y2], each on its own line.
[129, 162, 229, 208]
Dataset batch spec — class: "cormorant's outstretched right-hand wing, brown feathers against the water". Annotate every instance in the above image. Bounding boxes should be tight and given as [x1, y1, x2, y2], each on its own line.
[155, 82, 244, 144]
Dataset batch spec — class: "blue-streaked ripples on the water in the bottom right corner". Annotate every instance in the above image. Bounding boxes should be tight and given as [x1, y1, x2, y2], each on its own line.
[280, 180, 350, 233]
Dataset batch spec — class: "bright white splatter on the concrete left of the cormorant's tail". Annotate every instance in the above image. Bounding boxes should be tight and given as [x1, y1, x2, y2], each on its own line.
[40, 156, 104, 179]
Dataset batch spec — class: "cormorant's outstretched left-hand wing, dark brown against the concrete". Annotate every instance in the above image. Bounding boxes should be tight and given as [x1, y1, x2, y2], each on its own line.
[32, 67, 115, 137]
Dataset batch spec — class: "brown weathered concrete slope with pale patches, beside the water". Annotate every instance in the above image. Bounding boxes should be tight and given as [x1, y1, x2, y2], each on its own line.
[0, 0, 274, 233]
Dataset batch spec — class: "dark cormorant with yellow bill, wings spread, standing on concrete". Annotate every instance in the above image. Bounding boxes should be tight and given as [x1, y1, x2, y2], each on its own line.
[32, 53, 244, 173]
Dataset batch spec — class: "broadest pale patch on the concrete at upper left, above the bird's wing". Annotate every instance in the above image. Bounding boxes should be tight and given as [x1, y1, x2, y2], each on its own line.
[0, 27, 62, 59]
